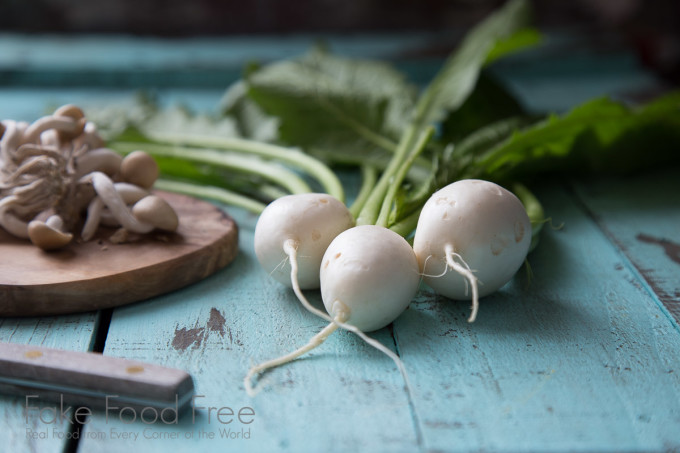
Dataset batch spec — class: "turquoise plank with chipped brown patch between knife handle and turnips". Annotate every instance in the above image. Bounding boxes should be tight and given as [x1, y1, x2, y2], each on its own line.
[80, 207, 417, 452]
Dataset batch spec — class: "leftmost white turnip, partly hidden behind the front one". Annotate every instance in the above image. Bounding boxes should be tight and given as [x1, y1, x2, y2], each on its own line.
[255, 193, 354, 316]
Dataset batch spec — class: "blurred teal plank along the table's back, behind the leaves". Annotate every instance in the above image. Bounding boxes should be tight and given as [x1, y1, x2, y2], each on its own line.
[0, 32, 441, 88]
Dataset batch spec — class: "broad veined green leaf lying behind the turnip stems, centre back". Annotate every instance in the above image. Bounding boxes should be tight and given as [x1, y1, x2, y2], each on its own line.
[247, 50, 415, 160]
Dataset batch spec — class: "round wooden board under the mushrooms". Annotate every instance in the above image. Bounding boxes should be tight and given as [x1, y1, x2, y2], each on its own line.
[0, 192, 238, 316]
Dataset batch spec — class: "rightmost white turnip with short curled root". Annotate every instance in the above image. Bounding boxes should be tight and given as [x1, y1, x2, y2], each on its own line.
[413, 179, 531, 322]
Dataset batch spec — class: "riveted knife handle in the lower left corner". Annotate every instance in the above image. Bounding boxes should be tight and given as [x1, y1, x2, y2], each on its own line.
[0, 343, 194, 411]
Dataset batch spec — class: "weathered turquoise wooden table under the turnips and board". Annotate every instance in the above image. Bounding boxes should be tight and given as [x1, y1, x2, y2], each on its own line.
[0, 34, 680, 452]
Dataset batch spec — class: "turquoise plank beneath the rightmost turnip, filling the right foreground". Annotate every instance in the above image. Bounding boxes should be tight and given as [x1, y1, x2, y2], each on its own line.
[395, 181, 680, 451]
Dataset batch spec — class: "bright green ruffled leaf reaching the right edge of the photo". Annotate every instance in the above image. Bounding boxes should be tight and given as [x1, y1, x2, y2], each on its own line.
[465, 93, 680, 181]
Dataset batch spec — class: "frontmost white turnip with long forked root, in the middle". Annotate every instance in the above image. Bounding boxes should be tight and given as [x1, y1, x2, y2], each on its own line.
[244, 225, 420, 395]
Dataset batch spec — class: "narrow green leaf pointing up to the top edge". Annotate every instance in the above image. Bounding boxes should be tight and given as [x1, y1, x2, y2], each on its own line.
[415, 0, 529, 125]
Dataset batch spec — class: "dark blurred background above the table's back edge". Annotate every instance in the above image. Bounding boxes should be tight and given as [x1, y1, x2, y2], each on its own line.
[0, 0, 680, 84]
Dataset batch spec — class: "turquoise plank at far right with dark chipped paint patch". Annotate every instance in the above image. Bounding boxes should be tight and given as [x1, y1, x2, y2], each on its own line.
[576, 168, 680, 323]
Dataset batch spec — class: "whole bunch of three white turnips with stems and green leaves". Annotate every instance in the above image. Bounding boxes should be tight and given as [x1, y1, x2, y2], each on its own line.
[91, 0, 680, 391]
